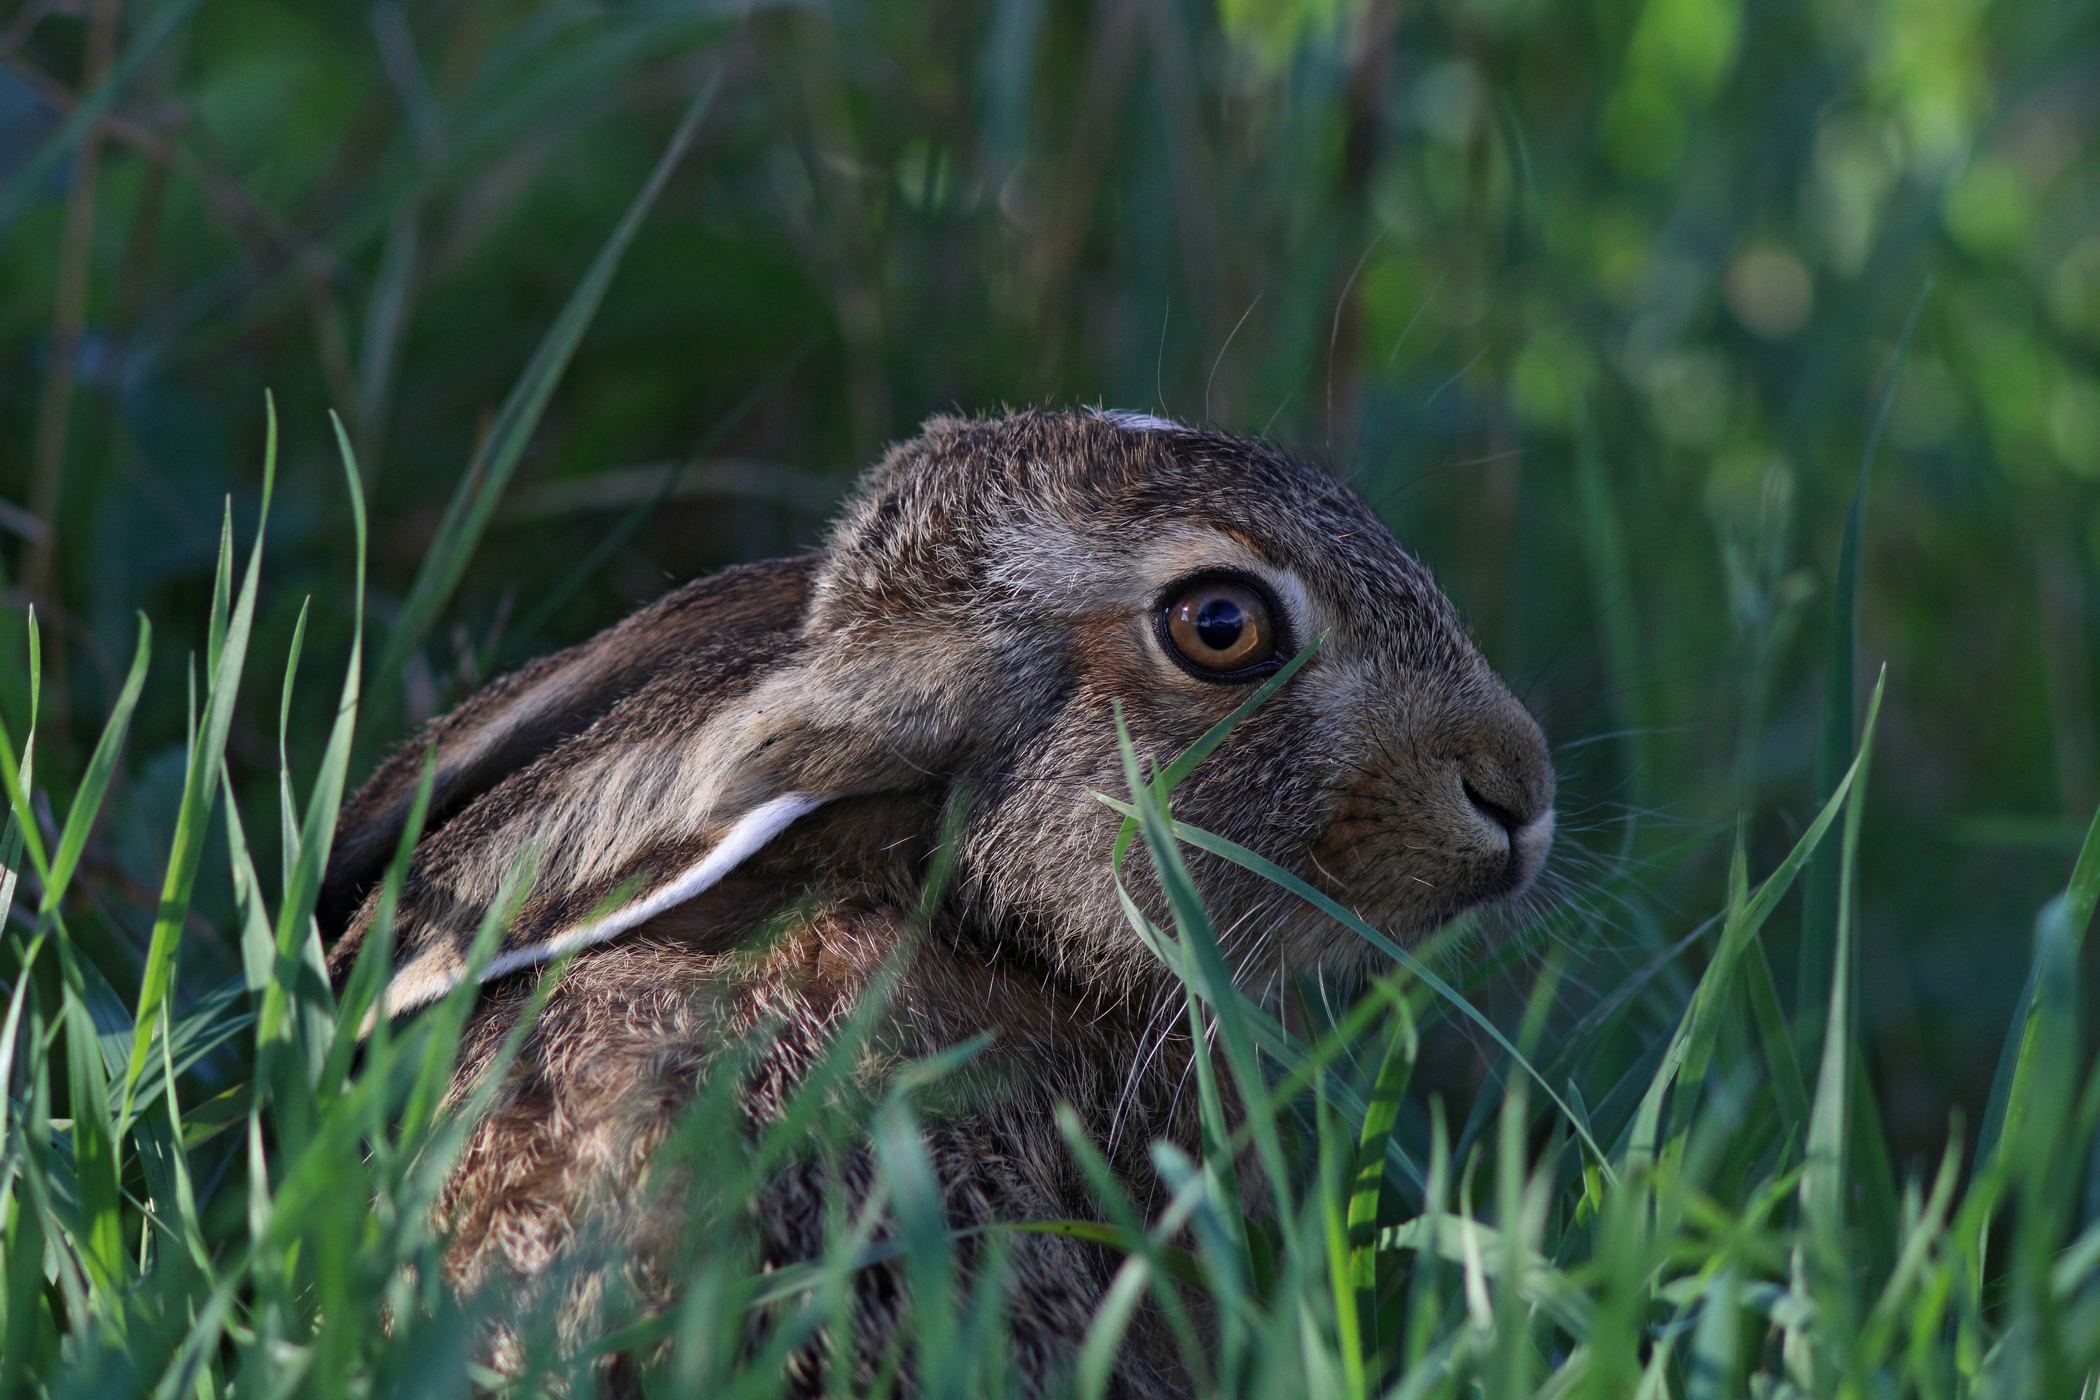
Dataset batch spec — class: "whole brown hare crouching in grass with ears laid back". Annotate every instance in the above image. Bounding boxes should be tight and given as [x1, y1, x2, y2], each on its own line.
[326, 413, 1552, 1396]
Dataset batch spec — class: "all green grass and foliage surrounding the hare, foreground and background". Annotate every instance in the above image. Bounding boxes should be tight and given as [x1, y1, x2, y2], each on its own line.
[0, 0, 2100, 1400]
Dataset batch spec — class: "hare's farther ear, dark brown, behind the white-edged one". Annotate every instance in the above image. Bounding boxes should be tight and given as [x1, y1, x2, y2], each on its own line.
[315, 558, 815, 934]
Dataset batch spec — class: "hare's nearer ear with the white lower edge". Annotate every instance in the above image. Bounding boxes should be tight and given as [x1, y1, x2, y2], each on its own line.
[344, 566, 985, 1016]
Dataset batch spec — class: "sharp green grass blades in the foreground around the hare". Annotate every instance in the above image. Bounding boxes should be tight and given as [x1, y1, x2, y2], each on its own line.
[12, 411, 2100, 1400]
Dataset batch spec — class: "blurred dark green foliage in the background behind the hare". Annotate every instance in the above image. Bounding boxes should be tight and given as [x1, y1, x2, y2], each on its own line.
[0, 0, 2100, 1154]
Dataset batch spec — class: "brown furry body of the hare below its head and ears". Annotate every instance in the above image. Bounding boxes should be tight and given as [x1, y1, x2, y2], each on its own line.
[437, 881, 1187, 1398]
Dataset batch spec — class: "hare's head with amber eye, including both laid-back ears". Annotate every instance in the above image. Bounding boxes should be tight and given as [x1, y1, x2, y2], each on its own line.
[328, 411, 1554, 1012]
